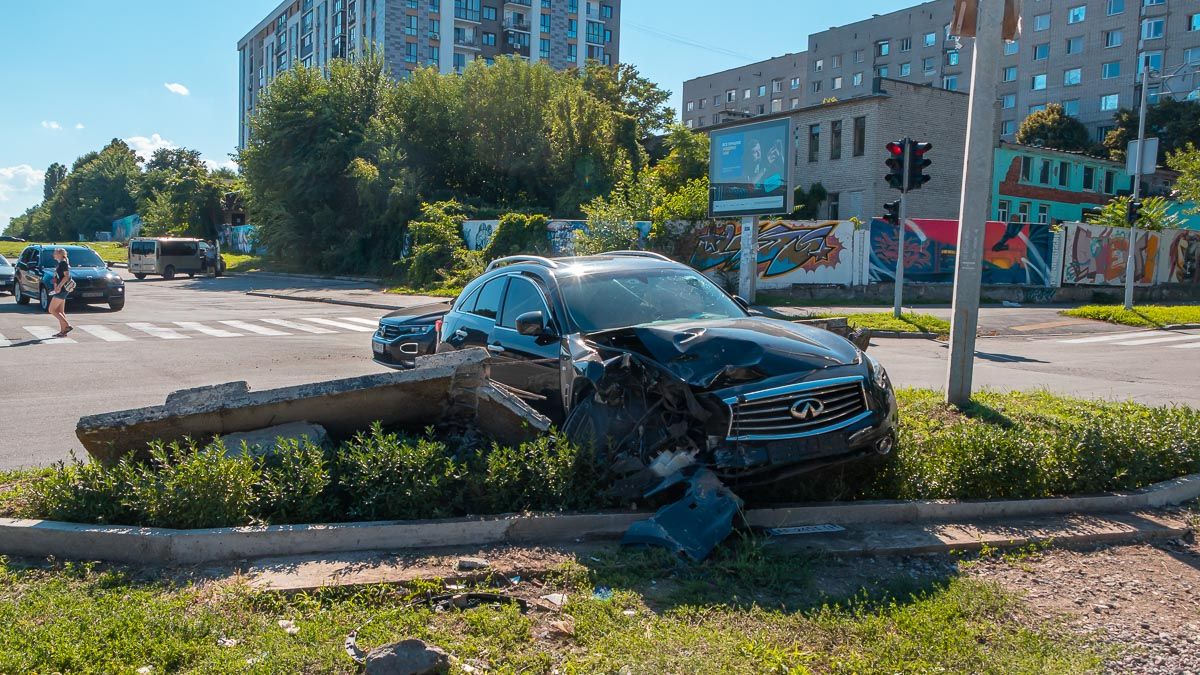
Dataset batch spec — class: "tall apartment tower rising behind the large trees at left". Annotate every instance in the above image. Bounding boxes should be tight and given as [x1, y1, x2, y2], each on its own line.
[238, 0, 620, 145]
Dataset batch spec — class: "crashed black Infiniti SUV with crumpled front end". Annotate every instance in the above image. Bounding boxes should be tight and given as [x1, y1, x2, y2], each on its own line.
[436, 251, 896, 485]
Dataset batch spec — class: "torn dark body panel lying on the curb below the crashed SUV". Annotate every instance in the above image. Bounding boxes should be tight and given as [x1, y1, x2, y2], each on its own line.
[622, 467, 742, 561]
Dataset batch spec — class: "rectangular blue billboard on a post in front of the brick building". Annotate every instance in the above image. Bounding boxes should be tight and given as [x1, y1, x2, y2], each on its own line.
[708, 118, 792, 217]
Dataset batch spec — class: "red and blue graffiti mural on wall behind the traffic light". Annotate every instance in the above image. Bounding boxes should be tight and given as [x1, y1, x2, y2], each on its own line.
[870, 219, 1054, 286]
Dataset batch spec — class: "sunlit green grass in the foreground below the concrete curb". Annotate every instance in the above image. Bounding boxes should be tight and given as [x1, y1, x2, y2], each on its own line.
[0, 542, 1103, 674]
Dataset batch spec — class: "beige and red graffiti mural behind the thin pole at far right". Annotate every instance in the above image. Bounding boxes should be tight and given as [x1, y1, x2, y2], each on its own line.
[1062, 222, 1158, 286]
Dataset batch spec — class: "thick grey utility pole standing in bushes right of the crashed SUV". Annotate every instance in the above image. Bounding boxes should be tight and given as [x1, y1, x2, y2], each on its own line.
[946, 0, 1006, 407]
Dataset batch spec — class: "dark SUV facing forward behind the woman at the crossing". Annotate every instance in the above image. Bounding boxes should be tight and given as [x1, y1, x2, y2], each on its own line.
[13, 244, 125, 311]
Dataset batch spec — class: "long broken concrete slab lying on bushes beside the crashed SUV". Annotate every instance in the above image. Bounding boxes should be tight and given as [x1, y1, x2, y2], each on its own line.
[76, 350, 550, 464]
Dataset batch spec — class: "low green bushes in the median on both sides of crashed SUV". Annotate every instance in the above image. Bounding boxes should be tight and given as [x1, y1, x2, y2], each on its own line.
[0, 389, 1200, 528]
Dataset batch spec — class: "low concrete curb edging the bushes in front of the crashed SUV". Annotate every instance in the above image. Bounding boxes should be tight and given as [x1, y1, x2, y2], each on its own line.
[0, 474, 1200, 566]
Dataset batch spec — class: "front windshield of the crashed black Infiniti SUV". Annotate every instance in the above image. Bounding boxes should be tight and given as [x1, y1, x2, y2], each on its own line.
[559, 269, 746, 333]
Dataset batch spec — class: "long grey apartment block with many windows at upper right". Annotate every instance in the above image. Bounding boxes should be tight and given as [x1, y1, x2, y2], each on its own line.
[683, 0, 1200, 141]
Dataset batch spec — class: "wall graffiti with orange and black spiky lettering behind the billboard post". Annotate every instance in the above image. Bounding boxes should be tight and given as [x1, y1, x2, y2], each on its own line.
[688, 220, 857, 288]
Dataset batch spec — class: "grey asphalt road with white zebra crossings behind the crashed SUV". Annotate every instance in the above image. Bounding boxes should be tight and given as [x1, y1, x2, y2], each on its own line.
[0, 270, 1200, 470]
